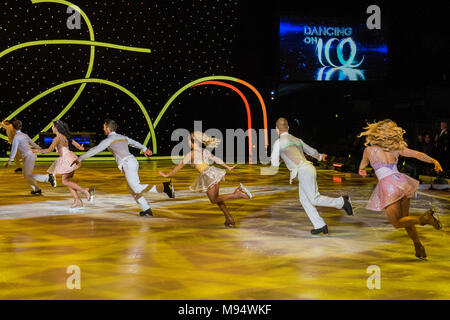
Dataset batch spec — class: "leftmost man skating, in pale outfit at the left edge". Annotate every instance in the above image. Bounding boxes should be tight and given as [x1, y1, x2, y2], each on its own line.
[6, 120, 56, 195]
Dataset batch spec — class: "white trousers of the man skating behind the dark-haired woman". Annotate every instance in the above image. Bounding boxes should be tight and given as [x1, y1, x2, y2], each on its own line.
[122, 157, 158, 211]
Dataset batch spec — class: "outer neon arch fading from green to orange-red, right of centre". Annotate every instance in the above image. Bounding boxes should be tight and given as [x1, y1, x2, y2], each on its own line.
[145, 76, 268, 146]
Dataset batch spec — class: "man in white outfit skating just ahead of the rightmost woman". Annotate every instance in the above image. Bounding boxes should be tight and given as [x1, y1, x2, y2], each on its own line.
[271, 118, 353, 234]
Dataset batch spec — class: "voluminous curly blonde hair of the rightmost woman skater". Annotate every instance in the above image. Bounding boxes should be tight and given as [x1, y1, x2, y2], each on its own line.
[358, 119, 408, 151]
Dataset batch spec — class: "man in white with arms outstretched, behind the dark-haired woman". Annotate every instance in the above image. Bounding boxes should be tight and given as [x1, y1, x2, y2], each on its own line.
[72, 119, 175, 216]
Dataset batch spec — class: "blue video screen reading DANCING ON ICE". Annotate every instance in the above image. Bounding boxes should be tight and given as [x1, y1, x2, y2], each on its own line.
[280, 16, 388, 81]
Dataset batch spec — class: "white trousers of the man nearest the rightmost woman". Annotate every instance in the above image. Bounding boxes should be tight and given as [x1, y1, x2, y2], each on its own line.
[298, 163, 344, 229]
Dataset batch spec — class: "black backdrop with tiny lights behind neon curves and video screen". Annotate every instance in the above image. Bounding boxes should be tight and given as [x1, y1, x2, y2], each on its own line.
[0, 0, 450, 154]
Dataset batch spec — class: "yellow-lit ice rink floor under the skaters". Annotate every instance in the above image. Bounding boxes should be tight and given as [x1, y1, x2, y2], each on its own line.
[0, 161, 450, 299]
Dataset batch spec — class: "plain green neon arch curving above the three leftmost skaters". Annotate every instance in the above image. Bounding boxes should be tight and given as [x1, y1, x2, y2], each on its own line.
[6, 79, 158, 154]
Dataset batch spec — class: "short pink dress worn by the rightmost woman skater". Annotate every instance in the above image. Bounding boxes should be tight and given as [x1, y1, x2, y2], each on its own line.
[366, 146, 419, 211]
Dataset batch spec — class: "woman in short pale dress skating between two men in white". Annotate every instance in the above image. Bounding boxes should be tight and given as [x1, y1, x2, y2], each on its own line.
[158, 132, 252, 228]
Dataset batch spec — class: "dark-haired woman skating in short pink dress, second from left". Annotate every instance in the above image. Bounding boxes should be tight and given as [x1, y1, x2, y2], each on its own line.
[33, 120, 95, 208]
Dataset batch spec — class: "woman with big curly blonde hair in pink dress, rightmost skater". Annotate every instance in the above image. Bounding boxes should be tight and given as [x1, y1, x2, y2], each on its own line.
[359, 119, 442, 259]
